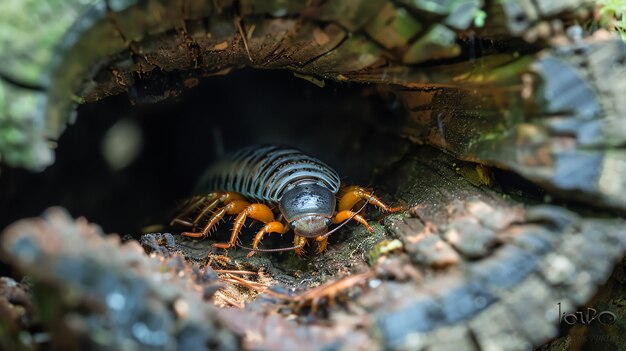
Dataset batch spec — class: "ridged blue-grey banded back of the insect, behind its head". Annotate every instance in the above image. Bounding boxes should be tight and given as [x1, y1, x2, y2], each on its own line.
[197, 145, 341, 205]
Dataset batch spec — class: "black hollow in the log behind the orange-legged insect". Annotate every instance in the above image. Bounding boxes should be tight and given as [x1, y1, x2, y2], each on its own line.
[0, 66, 541, 278]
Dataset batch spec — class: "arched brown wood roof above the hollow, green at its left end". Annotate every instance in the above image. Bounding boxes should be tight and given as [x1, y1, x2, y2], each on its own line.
[0, 0, 593, 169]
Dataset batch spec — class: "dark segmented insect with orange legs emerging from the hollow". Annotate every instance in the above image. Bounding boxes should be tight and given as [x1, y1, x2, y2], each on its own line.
[170, 145, 401, 256]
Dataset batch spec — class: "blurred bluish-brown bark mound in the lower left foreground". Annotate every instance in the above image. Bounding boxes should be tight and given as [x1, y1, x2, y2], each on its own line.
[0, 208, 241, 350]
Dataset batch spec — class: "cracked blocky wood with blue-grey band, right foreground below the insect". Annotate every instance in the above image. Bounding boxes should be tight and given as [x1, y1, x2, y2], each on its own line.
[144, 147, 626, 350]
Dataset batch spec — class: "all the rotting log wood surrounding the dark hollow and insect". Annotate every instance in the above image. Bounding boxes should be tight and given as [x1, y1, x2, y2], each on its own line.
[0, 0, 626, 350]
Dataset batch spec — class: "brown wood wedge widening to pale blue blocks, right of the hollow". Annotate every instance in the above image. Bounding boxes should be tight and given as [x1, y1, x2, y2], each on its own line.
[397, 38, 626, 210]
